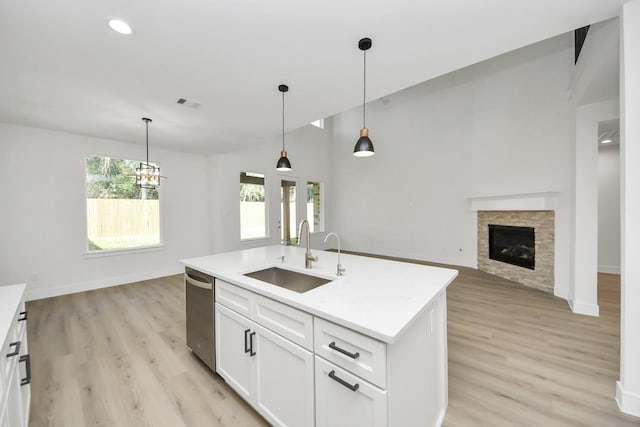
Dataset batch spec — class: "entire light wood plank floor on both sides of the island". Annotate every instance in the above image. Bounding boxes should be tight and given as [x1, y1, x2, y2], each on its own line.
[27, 268, 640, 427]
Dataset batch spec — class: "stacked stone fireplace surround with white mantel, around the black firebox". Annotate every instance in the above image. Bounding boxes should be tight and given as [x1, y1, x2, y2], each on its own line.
[469, 193, 556, 294]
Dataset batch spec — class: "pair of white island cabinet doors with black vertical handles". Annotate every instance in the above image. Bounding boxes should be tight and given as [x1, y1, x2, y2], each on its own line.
[215, 284, 314, 427]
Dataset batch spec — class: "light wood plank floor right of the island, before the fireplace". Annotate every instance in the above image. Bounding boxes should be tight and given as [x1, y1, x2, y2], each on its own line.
[444, 269, 640, 427]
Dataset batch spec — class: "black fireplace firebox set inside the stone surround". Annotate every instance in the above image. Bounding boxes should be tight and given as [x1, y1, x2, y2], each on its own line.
[489, 224, 536, 270]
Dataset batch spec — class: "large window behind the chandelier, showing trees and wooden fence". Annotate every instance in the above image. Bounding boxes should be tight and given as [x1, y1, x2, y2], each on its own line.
[86, 156, 160, 252]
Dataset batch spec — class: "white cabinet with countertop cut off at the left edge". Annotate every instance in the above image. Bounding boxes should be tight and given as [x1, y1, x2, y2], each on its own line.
[0, 285, 31, 427]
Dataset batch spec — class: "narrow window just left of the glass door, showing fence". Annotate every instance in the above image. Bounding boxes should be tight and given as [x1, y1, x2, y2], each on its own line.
[240, 172, 267, 240]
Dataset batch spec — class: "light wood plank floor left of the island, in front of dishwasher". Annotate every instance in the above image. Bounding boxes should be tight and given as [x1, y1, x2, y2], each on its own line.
[27, 276, 268, 427]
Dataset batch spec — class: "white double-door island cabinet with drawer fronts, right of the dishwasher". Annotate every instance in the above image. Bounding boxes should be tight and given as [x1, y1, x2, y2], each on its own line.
[215, 280, 314, 427]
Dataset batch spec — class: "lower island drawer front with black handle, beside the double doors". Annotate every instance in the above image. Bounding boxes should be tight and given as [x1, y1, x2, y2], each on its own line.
[316, 356, 389, 427]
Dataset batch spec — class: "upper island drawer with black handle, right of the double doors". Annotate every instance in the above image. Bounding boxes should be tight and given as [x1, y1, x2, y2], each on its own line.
[314, 317, 387, 388]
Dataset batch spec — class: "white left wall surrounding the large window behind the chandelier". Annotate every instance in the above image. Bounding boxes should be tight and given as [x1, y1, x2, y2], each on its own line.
[0, 124, 209, 299]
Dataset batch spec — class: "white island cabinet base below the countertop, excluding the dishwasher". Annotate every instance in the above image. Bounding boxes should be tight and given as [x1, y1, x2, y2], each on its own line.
[215, 280, 447, 427]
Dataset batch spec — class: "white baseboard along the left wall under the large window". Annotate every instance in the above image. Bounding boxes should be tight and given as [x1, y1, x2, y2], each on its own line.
[25, 266, 184, 301]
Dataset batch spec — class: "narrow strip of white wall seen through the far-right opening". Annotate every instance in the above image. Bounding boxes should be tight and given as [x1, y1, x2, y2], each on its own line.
[598, 145, 620, 274]
